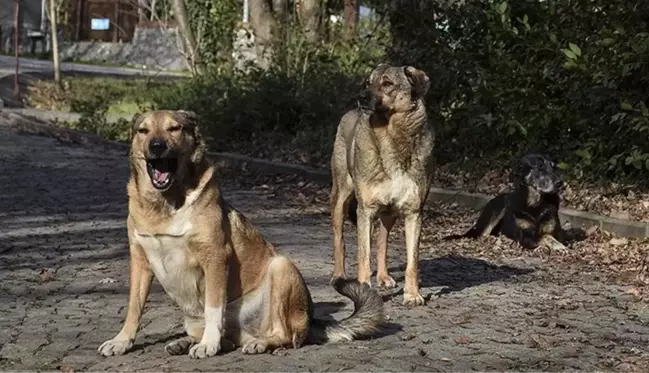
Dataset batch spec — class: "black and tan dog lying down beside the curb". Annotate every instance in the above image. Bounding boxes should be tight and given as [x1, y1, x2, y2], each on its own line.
[446, 154, 566, 251]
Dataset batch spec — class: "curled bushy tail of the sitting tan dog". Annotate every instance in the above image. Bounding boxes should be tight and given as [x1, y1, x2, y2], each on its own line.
[308, 278, 384, 343]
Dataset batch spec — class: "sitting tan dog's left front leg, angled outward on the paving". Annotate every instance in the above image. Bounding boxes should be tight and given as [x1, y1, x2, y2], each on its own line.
[97, 243, 153, 356]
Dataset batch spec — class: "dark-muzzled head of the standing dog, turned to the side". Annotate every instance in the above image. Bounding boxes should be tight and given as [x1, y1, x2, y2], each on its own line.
[359, 64, 430, 113]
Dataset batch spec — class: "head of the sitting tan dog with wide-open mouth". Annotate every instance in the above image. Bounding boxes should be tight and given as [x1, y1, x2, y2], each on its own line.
[131, 110, 206, 192]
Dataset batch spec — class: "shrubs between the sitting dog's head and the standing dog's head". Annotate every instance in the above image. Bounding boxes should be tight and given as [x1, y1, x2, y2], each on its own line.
[153, 23, 384, 163]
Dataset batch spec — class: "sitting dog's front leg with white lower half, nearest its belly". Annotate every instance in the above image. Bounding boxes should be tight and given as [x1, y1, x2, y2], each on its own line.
[189, 248, 228, 359]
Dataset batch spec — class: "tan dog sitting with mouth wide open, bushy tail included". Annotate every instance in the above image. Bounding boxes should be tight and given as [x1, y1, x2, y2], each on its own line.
[99, 111, 383, 358]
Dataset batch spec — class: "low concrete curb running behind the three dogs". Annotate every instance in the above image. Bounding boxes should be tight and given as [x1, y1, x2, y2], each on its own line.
[0, 109, 649, 237]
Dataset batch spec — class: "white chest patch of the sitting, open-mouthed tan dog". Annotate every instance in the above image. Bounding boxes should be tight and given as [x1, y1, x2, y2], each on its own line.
[134, 208, 204, 316]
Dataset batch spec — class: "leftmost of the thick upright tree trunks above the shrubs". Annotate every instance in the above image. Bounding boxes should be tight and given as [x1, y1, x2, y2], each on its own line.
[248, 0, 277, 68]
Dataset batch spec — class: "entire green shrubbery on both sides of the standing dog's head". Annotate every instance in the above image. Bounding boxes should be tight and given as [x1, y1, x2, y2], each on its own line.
[147, 0, 649, 180]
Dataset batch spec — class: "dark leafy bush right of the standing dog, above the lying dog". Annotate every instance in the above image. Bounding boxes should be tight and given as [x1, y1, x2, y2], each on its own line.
[389, 0, 649, 178]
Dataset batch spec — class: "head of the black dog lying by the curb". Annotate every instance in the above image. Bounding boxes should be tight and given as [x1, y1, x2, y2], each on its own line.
[510, 154, 563, 194]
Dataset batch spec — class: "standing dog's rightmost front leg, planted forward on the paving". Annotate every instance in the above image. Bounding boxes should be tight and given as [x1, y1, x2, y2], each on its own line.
[403, 211, 424, 306]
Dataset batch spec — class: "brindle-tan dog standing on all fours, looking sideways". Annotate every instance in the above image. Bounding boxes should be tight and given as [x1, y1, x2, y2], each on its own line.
[331, 64, 434, 305]
